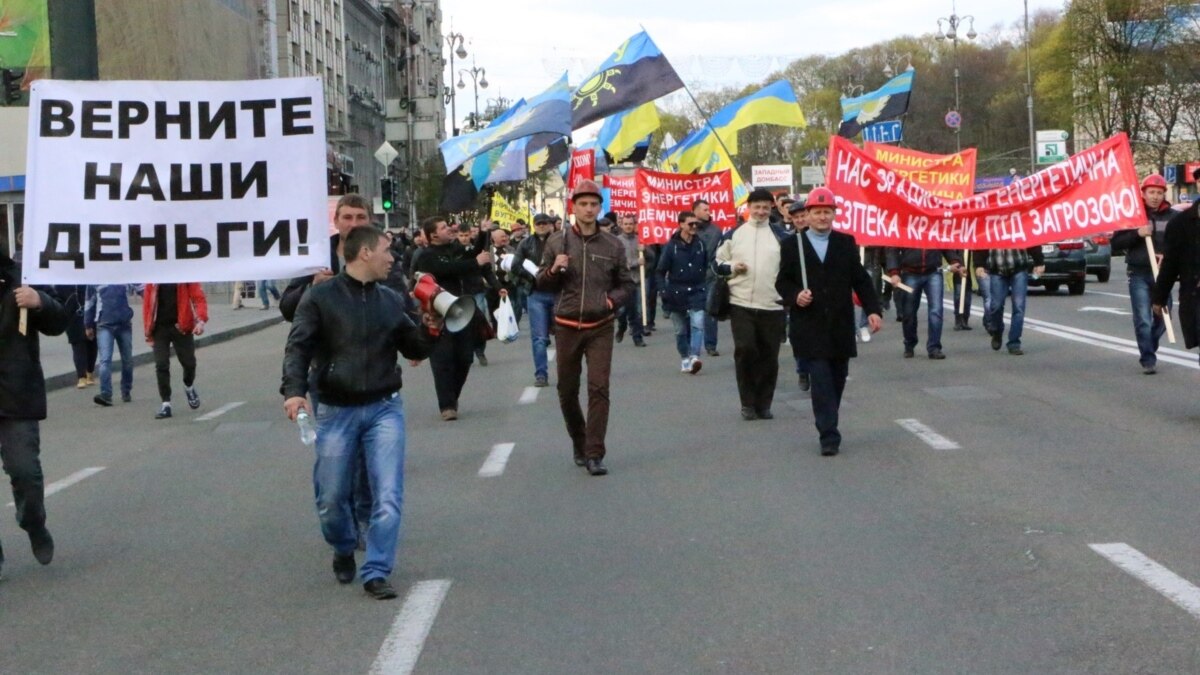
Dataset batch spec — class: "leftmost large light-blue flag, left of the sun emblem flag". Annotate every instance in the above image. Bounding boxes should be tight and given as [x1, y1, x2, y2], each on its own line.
[440, 73, 571, 173]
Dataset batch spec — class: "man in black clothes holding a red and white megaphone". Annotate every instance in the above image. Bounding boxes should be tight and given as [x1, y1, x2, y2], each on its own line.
[414, 216, 492, 422]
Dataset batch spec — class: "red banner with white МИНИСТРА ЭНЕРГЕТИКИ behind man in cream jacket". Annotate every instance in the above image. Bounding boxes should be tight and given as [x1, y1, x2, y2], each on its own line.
[634, 169, 738, 244]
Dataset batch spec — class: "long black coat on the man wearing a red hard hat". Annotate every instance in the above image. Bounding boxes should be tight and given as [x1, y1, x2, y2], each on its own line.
[775, 232, 882, 359]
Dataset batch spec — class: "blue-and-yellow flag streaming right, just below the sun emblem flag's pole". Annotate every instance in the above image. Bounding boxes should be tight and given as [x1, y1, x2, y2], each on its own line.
[664, 79, 808, 173]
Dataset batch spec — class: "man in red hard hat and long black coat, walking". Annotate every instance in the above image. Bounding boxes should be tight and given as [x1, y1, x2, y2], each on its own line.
[775, 187, 883, 456]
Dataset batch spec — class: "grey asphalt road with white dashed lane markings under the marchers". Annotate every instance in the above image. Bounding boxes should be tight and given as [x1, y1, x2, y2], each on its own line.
[0, 254, 1200, 674]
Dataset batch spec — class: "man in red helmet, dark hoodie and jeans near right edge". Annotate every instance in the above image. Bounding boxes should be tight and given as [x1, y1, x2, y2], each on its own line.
[1112, 173, 1175, 375]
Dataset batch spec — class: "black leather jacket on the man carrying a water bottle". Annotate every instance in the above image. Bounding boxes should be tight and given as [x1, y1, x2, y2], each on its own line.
[280, 273, 431, 406]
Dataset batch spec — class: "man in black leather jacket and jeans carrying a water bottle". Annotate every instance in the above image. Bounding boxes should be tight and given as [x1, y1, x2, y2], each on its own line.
[281, 226, 430, 599]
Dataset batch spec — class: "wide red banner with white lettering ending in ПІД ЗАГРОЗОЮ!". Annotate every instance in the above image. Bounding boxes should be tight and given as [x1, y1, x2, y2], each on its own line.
[827, 133, 1146, 249]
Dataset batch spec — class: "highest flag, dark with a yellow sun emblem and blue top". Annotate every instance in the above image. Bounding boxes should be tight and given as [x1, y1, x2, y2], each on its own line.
[571, 30, 683, 130]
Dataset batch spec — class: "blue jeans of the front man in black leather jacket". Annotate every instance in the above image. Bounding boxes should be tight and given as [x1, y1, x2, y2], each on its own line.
[312, 392, 404, 583]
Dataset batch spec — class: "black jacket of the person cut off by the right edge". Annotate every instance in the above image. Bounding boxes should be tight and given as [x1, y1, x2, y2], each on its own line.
[1154, 202, 1200, 350]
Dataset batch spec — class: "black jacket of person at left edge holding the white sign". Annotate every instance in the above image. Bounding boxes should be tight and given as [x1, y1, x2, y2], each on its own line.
[0, 256, 68, 419]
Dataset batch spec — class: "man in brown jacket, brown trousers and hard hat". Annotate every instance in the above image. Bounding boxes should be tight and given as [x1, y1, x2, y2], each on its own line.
[538, 180, 634, 476]
